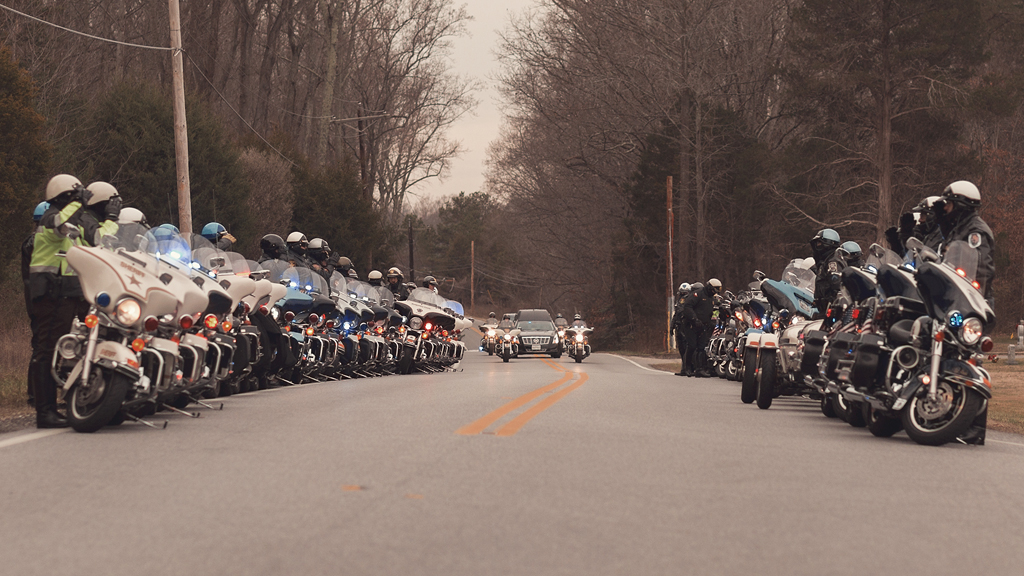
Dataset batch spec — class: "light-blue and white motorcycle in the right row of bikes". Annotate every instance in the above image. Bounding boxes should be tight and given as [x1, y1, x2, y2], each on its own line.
[746, 258, 820, 410]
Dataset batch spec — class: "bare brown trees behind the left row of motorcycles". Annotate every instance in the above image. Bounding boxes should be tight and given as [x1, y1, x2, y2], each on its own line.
[0, 0, 473, 274]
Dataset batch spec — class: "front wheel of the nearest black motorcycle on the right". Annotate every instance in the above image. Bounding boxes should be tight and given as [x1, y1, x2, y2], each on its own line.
[902, 380, 984, 446]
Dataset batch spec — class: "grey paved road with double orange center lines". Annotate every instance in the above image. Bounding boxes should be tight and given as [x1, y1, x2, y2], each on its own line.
[0, 344, 1024, 576]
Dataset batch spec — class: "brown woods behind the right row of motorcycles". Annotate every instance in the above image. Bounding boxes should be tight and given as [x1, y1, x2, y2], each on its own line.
[487, 0, 1024, 340]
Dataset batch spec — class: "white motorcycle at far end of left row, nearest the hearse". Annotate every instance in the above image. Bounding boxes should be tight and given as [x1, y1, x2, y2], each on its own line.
[394, 288, 456, 374]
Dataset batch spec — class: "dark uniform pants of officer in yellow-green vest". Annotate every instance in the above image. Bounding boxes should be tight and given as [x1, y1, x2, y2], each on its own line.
[29, 296, 89, 414]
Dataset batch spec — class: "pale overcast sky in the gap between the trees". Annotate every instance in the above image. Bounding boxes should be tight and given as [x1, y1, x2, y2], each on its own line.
[414, 0, 535, 203]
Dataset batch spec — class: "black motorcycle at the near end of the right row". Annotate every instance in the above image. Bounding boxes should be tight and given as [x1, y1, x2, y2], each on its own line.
[840, 239, 995, 446]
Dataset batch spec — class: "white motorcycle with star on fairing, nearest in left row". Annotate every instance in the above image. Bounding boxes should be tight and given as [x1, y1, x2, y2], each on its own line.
[52, 224, 209, 433]
